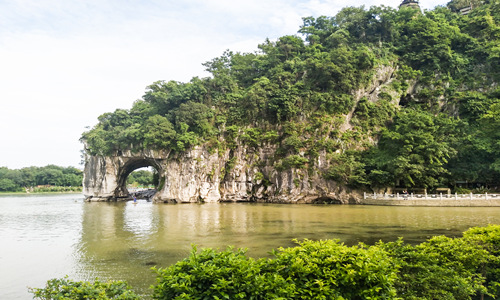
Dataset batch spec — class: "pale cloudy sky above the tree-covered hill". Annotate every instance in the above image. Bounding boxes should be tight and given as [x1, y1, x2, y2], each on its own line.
[0, 0, 447, 169]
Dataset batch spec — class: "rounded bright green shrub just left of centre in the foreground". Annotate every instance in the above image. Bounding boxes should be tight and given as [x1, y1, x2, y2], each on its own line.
[153, 247, 289, 299]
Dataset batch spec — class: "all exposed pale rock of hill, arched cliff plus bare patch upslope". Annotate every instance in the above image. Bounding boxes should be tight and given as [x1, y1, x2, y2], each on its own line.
[83, 66, 401, 203]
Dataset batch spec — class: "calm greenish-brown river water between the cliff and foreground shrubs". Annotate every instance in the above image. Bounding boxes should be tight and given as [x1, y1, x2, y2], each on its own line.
[0, 194, 500, 299]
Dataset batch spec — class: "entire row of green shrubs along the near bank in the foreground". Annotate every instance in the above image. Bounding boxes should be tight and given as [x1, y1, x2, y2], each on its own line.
[29, 225, 500, 299]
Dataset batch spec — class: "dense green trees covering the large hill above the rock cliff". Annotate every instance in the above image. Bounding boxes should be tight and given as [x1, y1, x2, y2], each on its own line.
[82, 0, 500, 188]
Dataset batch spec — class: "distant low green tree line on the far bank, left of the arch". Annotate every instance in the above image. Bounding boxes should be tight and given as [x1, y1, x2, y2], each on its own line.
[0, 165, 83, 192]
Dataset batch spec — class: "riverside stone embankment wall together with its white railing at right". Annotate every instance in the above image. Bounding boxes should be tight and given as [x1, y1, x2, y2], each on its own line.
[361, 193, 500, 206]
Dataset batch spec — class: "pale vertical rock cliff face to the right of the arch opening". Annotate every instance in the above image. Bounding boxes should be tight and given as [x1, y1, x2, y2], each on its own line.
[162, 145, 362, 203]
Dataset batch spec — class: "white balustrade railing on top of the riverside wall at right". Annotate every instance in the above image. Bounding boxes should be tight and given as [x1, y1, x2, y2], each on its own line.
[363, 192, 500, 200]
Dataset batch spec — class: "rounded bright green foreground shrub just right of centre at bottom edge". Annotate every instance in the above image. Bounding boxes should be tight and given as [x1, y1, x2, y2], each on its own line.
[271, 240, 397, 299]
